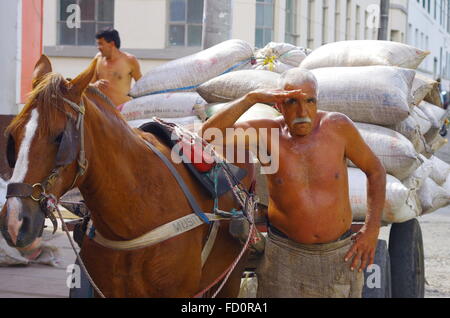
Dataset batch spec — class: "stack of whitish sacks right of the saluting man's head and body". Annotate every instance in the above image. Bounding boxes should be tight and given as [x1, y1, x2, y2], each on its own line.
[300, 40, 450, 223]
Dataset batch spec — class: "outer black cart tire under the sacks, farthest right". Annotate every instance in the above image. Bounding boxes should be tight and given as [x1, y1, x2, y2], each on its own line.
[389, 219, 425, 298]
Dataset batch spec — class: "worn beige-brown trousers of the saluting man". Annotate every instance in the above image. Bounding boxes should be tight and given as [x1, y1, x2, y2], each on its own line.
[256, 229, 364, 298]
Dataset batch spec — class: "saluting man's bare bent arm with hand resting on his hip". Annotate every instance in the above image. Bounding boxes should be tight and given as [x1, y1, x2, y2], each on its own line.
[339, 115, 386, 271]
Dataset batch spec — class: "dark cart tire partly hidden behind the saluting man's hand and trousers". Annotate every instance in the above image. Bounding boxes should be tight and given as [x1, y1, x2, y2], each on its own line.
[362, 240, 391, 298]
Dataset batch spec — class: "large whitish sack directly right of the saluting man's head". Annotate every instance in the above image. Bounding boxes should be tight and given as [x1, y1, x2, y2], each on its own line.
[312, 66, 415, 126]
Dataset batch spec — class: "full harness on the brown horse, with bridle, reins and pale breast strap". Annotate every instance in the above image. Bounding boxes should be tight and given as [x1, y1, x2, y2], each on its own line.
[6, 96, 256, 297]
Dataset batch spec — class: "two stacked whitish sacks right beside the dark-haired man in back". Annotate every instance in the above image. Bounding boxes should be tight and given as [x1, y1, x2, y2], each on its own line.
[121, 40, 253, 127]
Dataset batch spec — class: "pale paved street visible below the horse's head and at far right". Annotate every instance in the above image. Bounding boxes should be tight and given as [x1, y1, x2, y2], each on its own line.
[0, 206, 450, 297]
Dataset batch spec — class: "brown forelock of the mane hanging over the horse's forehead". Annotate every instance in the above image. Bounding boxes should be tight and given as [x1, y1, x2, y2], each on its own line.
[5, 73, 72, 135]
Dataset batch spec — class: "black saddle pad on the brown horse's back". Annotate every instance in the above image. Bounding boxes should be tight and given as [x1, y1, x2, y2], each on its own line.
[139, 122, 247, 198]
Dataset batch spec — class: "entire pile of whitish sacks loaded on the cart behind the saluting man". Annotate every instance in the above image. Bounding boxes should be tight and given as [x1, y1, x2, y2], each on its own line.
[128, 40, 450, 223]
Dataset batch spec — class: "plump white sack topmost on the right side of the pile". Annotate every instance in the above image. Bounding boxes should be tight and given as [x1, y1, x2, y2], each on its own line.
[300, 40, 430, 70]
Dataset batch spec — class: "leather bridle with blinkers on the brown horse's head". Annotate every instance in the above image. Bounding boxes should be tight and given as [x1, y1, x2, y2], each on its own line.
[6, 96, 88, 233]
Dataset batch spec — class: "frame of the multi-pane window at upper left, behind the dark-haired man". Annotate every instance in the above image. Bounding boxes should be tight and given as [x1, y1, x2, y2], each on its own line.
[56, 0, 115, 47]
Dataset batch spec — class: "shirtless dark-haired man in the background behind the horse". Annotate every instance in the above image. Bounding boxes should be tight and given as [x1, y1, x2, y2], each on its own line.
[92, 29, 142, 110]
